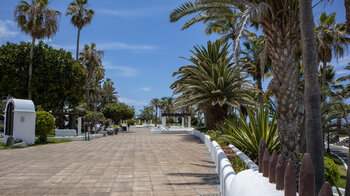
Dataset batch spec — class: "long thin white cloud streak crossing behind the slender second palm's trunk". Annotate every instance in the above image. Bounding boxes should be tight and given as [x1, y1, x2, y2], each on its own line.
[52, 42, 158, 52]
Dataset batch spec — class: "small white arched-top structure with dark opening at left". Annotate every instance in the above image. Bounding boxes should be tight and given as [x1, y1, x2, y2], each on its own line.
[4, 99, 36, 144]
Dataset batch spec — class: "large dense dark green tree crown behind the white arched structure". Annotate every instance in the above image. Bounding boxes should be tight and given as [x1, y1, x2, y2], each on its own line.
[0, 42, 86, 111]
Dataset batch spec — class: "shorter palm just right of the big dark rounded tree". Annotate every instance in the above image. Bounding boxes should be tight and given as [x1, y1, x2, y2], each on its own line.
[80, 43, 104, 110]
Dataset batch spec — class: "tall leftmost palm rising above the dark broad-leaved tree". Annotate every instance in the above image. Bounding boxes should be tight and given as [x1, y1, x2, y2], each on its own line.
[15, 0, 60, 99]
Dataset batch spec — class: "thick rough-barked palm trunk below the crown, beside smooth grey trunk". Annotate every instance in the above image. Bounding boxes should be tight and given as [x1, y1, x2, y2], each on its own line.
[264, 28, 301, 174]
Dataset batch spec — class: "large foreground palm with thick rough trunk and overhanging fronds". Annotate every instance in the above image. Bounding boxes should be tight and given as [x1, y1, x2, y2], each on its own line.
[170, 0, 300, 177]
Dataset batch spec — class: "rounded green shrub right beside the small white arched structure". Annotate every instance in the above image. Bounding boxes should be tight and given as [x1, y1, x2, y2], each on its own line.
[35, 111, 55, 142]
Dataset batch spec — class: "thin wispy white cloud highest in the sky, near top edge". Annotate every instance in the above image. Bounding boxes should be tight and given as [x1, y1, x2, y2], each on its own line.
[96, 7, 172, 18]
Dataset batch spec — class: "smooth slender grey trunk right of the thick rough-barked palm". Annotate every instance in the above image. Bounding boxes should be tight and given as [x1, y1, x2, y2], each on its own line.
[299, 0, 325, 195]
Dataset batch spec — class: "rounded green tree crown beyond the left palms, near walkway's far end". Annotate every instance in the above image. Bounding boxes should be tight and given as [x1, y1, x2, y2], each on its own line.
[102, 103, 135, 124]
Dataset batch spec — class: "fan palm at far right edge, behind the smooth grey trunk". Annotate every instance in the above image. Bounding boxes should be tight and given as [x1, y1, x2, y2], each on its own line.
[315, 12, 350, 102]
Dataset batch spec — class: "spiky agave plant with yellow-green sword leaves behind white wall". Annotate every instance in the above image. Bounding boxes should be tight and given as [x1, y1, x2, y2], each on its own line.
[220, 105, 280, 160]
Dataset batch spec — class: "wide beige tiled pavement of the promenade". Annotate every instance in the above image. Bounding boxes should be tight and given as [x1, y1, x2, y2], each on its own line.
[0, 128, 219, 196]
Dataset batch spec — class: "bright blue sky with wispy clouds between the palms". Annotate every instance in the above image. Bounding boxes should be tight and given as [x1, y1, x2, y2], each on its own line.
[0, 0, 350, 111]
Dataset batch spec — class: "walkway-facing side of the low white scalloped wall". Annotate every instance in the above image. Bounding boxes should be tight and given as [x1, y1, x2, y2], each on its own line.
[192, 130, 236, 196]
